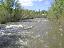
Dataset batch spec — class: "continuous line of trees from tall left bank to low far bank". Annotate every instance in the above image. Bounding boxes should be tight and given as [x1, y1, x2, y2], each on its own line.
[0, 0, 47, 23]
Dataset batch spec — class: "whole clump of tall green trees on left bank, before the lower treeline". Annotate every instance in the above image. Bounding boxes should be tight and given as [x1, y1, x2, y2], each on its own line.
[0, 0, 21, 23]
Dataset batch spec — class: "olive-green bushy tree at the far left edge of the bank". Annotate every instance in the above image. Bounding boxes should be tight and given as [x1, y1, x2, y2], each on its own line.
[0, 1, 8, 23]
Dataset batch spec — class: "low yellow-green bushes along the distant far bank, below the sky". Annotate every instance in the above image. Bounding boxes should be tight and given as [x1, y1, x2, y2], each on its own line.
[22, 9, 47, 19]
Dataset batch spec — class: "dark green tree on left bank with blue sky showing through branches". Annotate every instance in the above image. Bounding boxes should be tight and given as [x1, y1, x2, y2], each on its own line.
[6, 0, 21, 21]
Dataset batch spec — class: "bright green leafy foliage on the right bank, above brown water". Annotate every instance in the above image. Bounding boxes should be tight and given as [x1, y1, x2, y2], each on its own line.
[48, 0, 64, 19]
